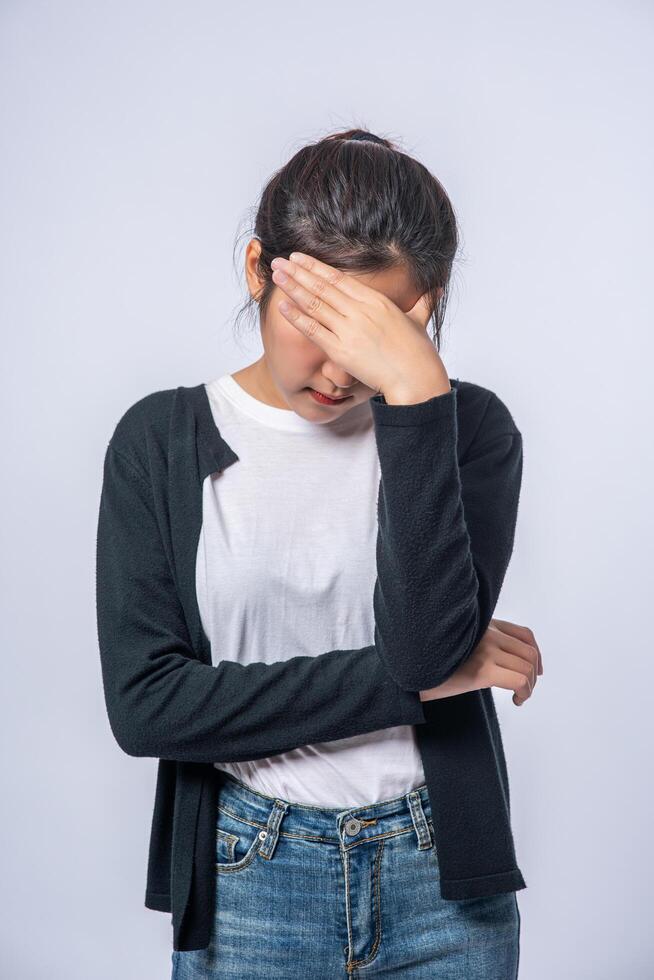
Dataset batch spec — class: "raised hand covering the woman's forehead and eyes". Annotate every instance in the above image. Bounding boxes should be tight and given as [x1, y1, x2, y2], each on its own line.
[271, 252, 451, 403]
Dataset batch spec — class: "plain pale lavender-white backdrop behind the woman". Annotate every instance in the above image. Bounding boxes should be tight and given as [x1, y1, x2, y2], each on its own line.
[0, 0, 654, 980]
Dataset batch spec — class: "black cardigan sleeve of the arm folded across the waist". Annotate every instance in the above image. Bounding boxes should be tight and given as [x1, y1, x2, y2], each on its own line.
[96, 442, 426, 763]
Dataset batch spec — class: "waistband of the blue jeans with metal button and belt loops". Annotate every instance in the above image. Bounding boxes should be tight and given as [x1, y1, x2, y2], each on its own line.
[215, 769, 432, 850]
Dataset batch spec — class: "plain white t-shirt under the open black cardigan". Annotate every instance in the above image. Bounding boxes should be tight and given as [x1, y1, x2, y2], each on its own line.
[196, 374, 425, 808]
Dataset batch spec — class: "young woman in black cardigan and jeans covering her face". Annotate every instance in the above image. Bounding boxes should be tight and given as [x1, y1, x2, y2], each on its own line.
[96, 130, 542, 980]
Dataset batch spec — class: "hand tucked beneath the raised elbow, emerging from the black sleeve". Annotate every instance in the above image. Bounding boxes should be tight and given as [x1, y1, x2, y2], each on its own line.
[420, 619, 543, 705]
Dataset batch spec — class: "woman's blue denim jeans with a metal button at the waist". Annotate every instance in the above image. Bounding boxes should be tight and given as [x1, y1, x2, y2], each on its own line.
[172, 772, 520, 980]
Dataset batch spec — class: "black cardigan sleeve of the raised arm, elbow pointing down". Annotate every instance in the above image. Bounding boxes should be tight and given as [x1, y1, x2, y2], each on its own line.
[371, 387, 522, 691]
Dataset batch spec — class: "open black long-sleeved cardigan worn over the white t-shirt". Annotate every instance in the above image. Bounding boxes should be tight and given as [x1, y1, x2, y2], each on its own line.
[96, 379, 526, 950]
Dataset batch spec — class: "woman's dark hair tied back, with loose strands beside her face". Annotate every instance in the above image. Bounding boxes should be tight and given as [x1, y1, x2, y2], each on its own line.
[236, 129, 459, 350]
